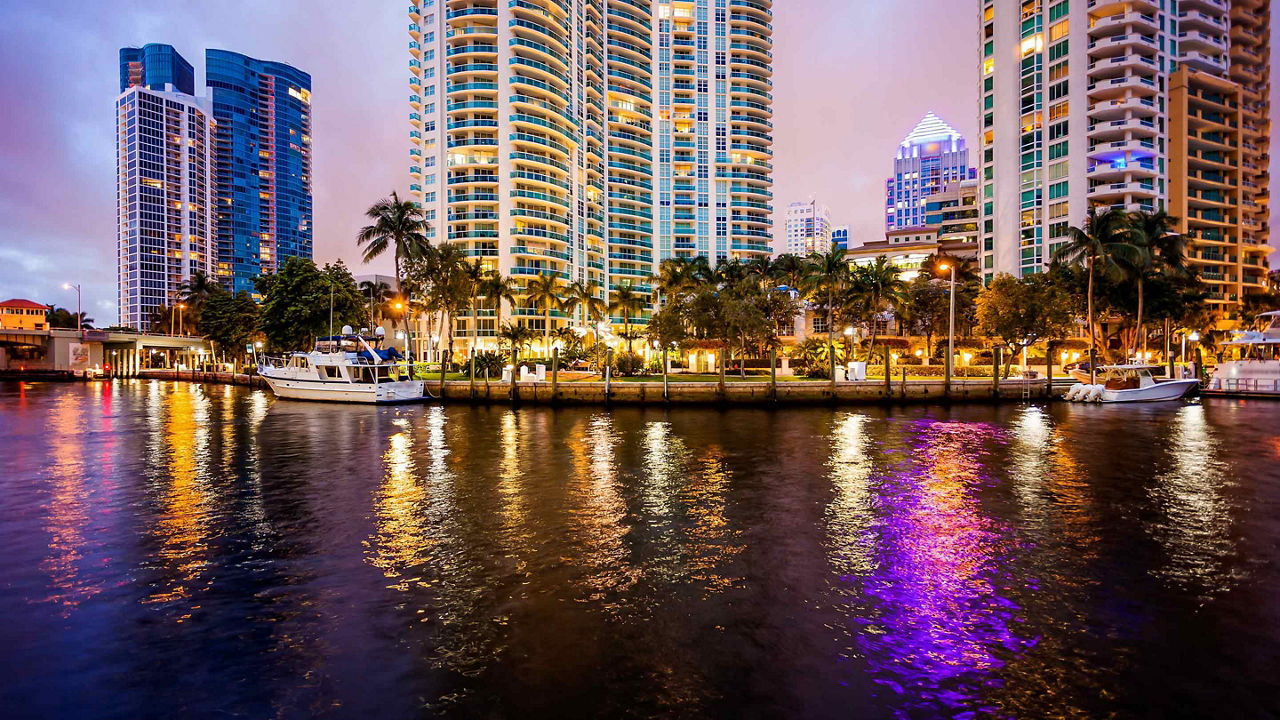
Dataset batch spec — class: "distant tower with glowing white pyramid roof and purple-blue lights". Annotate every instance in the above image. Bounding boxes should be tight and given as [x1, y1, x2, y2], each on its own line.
[884, 113, 974, 231]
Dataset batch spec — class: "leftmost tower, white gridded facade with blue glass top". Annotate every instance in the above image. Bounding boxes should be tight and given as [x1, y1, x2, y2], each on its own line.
[115, 45, 216, 329]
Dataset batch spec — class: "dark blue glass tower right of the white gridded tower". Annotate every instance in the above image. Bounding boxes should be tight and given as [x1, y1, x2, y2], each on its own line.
[205, 50, 312, 293]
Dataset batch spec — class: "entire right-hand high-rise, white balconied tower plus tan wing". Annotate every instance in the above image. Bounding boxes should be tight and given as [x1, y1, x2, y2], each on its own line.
[978, 0, 1270, 304]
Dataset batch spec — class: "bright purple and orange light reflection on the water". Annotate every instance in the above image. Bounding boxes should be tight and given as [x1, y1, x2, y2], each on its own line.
[859, 421, 1027, 715]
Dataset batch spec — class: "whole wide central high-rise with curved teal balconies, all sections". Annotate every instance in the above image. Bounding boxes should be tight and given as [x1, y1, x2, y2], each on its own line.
[408, 0, 771, 346]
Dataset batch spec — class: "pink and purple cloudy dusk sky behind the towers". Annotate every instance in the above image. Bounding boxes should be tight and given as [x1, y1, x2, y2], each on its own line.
[0, 0, 1275, 319]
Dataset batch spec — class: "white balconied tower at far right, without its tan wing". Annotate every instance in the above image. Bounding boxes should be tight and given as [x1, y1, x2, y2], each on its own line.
[978, 0, 1270, 285]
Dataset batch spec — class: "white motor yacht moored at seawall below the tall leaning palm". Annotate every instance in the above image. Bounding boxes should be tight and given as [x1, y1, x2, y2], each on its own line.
[257, 325, 426, 404]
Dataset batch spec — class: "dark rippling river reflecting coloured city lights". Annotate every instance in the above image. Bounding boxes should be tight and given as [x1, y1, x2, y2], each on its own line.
[0, 380, 1280, 719]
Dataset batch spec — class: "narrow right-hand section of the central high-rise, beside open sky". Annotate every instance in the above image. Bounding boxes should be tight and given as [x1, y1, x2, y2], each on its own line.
[654, 0, 773, 264]
